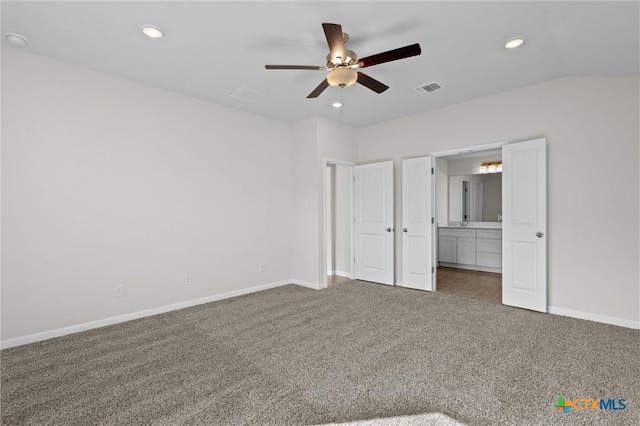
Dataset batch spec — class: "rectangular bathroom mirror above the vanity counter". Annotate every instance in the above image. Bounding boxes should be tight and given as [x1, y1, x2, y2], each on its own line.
[449, 173, 502, 222]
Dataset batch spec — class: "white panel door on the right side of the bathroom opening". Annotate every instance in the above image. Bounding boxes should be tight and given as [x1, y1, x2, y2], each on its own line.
[502, 139, 547, 312]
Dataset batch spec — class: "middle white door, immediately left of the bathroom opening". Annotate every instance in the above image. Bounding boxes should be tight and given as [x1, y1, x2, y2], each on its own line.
[402, 157, 433, 291]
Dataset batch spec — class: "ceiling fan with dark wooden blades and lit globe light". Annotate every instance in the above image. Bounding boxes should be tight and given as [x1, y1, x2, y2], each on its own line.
[265, 23, 422, 98]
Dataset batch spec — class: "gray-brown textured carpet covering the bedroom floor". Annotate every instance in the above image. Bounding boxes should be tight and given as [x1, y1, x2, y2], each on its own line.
[1, 281, 640, 425]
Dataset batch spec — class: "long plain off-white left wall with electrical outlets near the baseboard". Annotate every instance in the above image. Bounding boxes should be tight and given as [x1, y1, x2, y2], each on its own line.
[2, 48, 292, 339]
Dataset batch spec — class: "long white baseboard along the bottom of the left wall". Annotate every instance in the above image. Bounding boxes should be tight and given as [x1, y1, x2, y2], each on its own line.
[0, 280, 292, 349]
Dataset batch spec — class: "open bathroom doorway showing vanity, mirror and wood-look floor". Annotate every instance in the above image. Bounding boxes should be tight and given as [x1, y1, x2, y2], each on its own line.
[435, 147, 502, 303]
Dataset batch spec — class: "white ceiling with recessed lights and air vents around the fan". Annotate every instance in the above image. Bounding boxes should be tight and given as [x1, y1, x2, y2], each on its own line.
[2, 1, 640, 127]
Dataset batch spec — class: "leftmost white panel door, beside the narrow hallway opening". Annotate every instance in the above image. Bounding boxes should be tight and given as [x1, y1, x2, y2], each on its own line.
[354, 161, 394, 285]
